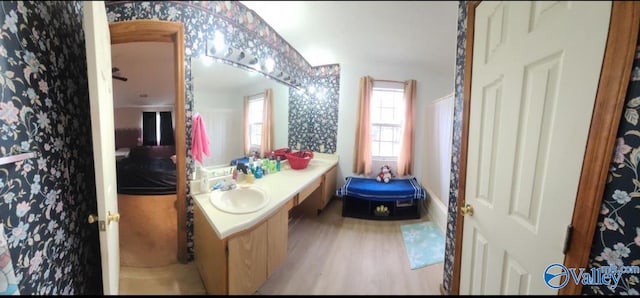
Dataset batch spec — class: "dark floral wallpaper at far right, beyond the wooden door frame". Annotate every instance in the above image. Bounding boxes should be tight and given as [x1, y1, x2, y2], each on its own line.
[582, 33, 640, 295]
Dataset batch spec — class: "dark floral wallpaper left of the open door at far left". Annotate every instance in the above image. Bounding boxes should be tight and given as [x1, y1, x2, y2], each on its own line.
[0, 1, 102, 295]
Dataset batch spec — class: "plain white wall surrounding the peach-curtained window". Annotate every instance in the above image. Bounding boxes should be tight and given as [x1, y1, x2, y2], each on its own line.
[337, 61, 454, 187]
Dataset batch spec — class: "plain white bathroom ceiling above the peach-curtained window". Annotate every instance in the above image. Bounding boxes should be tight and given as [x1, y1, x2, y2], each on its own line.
[240, 1, 458, 71]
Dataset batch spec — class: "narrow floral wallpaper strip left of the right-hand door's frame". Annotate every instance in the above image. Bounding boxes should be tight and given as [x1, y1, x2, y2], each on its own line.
[442, 1, 467, 293]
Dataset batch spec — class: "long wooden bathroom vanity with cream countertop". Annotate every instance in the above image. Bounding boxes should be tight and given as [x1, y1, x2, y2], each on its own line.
[193, 153, 338, 295]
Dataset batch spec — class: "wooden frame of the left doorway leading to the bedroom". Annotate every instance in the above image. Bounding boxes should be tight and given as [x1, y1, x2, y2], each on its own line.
[109, 20, 187, 264]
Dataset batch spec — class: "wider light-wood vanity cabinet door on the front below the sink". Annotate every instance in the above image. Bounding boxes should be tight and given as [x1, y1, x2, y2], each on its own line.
[228, 221, 268, 295]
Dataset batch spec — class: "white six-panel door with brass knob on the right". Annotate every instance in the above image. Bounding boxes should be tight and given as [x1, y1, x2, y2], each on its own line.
[460, 1, 611, 295]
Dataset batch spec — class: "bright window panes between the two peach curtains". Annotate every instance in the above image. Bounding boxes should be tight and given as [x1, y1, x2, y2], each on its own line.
[370, 86, 405, 160]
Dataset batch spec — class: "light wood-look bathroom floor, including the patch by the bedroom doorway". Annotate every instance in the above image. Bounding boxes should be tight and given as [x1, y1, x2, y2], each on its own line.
[120, 199, 444, 295]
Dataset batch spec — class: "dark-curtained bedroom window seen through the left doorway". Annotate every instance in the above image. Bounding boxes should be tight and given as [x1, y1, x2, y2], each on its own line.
[142, 112, 175, 146]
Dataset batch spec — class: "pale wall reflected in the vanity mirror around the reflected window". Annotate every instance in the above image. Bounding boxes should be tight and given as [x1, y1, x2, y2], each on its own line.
[191, 55, 289, 167]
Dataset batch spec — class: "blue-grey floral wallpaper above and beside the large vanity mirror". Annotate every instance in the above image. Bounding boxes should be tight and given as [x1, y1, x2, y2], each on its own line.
[106, 1, 340, 259]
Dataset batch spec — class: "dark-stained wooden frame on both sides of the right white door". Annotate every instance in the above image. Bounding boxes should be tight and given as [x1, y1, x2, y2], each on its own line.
[449, 1, 640, 295]
